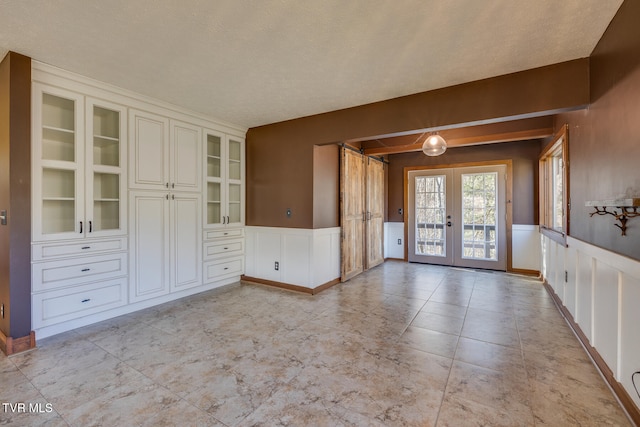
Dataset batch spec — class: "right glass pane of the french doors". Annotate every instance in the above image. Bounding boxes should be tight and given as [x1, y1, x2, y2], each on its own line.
[462, 172, 498, 260]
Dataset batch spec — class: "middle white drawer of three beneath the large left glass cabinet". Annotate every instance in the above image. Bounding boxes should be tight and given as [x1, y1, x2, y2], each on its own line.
[31, 252, 127, 292]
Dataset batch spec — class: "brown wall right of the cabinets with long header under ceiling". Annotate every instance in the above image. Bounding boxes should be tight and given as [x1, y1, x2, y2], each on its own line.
[247, 58, 589, 228]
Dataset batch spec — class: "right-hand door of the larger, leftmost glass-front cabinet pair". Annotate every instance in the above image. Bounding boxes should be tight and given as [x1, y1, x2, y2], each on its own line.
[86, 99, 127, 237]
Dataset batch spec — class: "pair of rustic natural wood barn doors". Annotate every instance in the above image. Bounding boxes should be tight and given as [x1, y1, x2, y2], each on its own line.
[340, 147, 384, 282]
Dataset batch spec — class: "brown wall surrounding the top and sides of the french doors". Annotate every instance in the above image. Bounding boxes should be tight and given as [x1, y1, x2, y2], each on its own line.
[388, 140, 540, 224]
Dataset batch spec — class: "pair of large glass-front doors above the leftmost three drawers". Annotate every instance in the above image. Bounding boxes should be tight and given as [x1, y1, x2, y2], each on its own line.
[32, 84, 127, 241]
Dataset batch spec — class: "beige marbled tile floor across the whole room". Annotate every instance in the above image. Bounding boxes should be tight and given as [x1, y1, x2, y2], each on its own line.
[0, 261, 630, 427]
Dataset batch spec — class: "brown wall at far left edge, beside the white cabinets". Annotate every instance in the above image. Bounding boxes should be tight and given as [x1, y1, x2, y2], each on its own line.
[0, 52, 31, 344]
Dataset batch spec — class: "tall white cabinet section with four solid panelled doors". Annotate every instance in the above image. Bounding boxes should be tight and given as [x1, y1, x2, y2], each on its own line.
[129, 111, 202, 301]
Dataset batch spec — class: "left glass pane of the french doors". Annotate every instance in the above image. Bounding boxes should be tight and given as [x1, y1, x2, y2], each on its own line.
[415, 175, 446, 257]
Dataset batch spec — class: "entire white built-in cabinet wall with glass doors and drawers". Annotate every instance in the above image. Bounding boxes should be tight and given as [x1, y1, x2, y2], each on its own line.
[31, 61, 245, 337]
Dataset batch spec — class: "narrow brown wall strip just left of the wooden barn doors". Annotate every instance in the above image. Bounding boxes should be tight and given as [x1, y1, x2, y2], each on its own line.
[313, 144, 340, 228]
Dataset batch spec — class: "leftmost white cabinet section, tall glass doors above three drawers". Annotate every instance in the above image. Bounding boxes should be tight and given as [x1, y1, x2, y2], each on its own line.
[32, 83, 128, 329]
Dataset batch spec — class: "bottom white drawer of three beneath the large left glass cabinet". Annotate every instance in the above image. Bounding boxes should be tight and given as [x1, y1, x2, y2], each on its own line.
[32, 277, 127, 329]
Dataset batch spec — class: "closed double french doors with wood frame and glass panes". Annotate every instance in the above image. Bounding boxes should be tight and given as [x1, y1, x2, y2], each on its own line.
[408, 165, 507, 271]
